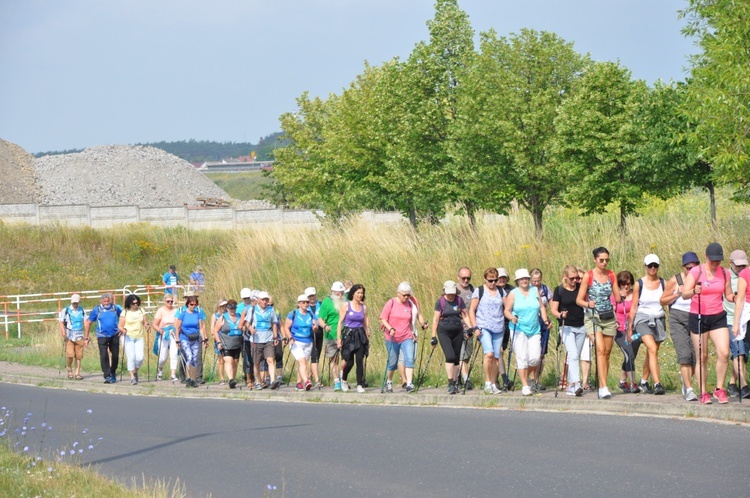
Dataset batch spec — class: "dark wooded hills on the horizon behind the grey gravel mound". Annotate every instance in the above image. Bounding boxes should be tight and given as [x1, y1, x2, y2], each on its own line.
[34, 132, 288, 163]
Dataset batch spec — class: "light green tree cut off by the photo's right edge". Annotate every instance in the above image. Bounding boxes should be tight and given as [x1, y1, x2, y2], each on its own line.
[681, 0, 750, 202]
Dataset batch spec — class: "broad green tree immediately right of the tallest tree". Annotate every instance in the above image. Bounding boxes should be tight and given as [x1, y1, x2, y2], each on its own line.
[455, 29, 589, 236]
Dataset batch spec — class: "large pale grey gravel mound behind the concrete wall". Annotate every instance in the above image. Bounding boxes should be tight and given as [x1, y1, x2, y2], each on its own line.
[34, 145, 235, 207]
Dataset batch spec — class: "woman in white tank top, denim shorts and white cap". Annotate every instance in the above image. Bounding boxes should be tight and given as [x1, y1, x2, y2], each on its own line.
[627, 254, 667, 395]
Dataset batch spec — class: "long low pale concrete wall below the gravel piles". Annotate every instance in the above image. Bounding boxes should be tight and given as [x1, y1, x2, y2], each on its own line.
[0, 204, 407, 229]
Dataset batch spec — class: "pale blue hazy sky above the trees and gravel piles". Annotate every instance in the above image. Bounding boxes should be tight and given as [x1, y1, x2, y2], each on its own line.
[0, 0, 697, 153]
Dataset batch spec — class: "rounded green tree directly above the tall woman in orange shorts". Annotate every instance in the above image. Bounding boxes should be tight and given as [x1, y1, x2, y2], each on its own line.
[555, 62, 651, 235]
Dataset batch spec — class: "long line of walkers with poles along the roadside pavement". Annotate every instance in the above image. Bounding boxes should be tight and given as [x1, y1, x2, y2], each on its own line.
[59, 243, 750, 404]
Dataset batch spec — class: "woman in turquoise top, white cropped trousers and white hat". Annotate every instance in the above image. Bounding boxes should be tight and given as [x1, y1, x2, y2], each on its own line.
[505, 268, 549, 396]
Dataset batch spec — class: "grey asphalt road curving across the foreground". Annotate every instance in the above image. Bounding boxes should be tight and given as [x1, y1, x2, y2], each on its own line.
[0, 384, 750, 497]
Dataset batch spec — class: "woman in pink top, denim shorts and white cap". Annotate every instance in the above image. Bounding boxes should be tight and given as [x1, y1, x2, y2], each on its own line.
[380, 282, 419, 393]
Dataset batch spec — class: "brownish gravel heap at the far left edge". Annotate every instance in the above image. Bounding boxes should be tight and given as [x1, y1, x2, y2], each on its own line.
[0, 139, 42, 204]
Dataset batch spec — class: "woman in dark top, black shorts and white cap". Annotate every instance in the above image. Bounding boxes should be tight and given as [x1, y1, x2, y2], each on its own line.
[430, 280, 471, 394]
